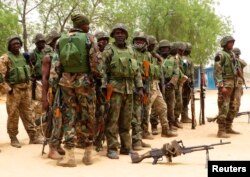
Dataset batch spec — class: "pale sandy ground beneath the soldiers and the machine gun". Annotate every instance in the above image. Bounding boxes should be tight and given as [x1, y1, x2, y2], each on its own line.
[0, 89, 250, 177]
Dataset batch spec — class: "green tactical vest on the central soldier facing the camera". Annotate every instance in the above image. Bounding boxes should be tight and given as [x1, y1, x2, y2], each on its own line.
[110, 45, 139, 78]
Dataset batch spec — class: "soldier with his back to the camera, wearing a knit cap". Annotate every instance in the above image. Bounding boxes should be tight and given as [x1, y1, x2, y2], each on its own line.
[57, 14, 98, 167]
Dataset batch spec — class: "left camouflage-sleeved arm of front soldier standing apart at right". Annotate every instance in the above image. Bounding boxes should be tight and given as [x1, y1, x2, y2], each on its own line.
[214, 54, 223, 87]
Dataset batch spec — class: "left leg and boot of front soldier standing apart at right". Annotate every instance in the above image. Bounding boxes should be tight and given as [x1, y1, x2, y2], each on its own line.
[217, 88, 232, 138]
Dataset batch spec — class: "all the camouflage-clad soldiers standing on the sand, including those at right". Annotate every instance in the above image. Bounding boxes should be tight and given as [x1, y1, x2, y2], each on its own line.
[0, 14, 246, 167]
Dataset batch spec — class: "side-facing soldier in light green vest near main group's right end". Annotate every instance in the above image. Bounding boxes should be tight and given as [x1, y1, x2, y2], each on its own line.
[159, 40, 181, 130]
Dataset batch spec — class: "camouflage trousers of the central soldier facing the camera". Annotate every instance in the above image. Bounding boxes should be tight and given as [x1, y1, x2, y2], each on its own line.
[106, 92, 133, 152]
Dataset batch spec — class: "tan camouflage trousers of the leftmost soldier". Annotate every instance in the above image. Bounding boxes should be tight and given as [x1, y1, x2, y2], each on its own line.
[6, 88, 37, 138]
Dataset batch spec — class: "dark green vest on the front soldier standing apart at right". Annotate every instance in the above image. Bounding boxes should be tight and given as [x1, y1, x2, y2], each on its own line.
[220, 51, 239, 79]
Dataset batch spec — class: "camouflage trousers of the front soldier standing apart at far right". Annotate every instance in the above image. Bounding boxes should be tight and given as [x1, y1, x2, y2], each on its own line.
[217, 87, 242, 125]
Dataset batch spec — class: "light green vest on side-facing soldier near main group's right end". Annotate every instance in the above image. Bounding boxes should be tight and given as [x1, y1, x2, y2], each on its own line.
[162, 56, 176, 78]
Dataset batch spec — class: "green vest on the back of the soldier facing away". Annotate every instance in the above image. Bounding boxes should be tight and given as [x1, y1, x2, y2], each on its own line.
[59, 32, 90, 73]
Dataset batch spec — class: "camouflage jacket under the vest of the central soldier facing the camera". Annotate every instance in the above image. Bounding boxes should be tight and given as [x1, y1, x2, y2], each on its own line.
[102, 43, 143, 94]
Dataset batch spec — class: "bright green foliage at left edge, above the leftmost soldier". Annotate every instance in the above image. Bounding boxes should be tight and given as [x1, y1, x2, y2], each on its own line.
[0, 2, 20, 54]
